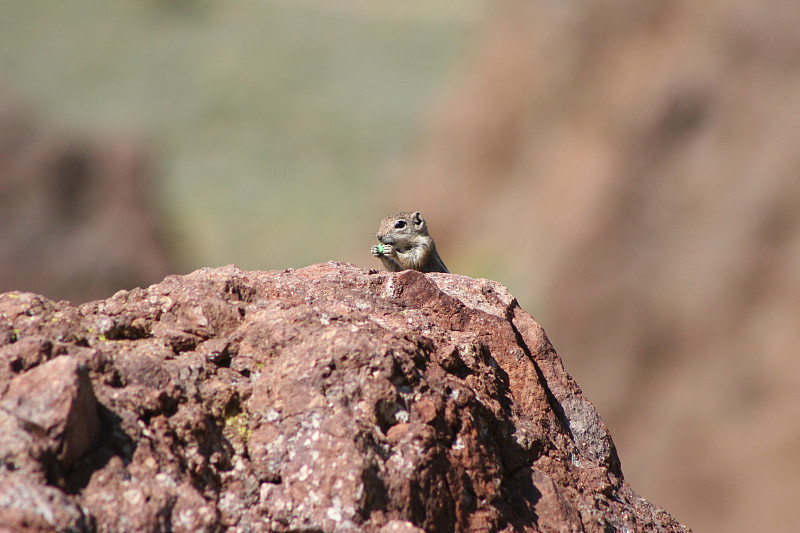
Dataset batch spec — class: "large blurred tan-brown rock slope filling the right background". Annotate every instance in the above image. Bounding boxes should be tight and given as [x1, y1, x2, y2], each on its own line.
[394, 0, 800, 532]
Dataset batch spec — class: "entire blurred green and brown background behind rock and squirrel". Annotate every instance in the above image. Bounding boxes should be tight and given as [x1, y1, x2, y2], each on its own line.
[0, 0, 800, 532]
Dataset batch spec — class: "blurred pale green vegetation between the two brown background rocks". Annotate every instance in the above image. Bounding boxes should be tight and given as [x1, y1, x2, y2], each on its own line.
[0, 0, 484, 270]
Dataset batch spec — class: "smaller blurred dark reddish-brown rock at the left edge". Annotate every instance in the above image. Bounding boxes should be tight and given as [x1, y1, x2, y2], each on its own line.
[0, 93, 174, 304]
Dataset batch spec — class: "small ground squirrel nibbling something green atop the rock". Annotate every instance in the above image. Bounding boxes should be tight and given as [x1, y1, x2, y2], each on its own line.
[371, 211, 449, 272]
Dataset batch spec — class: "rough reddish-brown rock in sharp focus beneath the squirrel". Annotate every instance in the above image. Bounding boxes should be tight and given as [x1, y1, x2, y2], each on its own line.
[0, 263, 687, 533]
